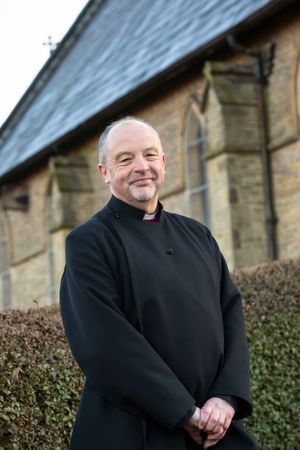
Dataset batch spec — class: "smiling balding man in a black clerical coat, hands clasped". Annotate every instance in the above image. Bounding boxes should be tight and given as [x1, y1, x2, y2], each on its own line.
[61, 117, 257, 450]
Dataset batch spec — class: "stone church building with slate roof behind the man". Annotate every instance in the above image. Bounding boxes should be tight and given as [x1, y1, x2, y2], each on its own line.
[0, 0, 300, 308]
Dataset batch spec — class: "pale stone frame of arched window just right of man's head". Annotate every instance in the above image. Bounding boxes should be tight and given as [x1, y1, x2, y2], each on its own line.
[182, 99, 210, 226]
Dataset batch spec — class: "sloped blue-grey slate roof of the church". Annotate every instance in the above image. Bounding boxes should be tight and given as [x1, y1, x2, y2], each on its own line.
[0, 0, 286, 179]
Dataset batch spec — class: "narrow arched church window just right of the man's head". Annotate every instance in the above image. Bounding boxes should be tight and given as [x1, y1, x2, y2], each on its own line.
[184, 103, 210, 226]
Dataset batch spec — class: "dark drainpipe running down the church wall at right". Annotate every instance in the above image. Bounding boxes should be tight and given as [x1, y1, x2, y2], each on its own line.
[227, 35, 277, 261]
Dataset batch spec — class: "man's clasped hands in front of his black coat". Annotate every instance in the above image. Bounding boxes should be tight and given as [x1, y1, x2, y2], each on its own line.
[184, 397, 235, 448]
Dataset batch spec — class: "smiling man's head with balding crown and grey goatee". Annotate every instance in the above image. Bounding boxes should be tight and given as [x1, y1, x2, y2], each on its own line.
[99, 122, 165, 213]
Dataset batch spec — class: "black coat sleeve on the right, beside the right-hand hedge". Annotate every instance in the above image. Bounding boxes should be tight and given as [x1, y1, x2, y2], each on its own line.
[209, 234, 252, 420]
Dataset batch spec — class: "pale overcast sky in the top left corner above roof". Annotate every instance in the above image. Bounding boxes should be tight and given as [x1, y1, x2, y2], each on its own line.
[0, 0, 88, 126]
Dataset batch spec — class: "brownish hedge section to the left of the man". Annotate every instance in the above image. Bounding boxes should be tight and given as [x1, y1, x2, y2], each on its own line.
[0, 306, 82, 450]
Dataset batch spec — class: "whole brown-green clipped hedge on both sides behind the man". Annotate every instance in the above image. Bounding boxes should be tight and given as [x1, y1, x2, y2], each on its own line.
[0, 260, 300, 450]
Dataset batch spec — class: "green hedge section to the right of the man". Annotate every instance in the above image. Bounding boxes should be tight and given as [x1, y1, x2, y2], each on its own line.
[234, 259, 300, 450]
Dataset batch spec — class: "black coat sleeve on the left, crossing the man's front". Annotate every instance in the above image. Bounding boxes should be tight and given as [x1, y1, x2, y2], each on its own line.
[60, 232, 195, 429]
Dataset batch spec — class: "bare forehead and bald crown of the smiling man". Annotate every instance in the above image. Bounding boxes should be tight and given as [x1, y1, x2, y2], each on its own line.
[107, 122, 162, 156]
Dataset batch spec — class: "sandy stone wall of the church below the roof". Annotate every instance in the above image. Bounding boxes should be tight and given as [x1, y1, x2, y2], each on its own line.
[0, 8, 300, 307]
